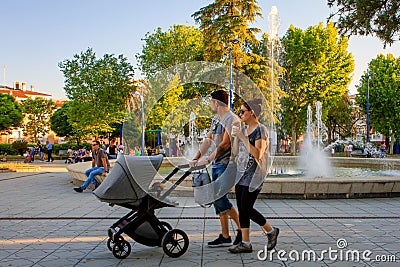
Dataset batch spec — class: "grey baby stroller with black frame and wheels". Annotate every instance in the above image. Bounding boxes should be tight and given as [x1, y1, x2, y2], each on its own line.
[93, 155, 204, 259]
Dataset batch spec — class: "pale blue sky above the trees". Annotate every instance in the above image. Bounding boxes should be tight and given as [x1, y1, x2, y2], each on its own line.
[0, 0, 400, 99]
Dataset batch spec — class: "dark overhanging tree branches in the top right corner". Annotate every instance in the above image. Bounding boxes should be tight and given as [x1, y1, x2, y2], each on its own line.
[328, 0, 400, 46]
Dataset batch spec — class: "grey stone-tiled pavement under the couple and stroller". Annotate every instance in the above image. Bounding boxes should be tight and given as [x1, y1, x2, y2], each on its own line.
[0, 161, 400, 267]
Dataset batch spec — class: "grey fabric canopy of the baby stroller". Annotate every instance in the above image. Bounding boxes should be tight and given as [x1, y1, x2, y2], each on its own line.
[93, 155, 163, 206]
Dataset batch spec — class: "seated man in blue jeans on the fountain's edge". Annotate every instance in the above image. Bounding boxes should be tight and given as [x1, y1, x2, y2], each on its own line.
[74, 140, 110, 193]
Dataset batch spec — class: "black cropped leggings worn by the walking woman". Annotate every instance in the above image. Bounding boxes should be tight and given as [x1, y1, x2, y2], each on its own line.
[235, 185, 267, 228]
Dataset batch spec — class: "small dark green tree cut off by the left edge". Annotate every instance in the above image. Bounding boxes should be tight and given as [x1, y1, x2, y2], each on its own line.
[0, 94, 23, 131]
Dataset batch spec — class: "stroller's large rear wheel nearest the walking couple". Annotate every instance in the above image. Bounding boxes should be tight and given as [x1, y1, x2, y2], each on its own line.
[161, 229, 189, 258]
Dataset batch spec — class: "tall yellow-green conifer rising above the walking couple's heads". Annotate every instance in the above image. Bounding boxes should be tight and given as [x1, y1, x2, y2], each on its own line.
[192, 0, 284, 112]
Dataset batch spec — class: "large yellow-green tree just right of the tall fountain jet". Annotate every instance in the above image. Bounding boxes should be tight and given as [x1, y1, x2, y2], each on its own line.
[281, 23, 354, 153]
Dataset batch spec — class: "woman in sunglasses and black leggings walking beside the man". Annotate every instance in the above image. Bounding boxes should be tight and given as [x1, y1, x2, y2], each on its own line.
[229, 98, 279, 253]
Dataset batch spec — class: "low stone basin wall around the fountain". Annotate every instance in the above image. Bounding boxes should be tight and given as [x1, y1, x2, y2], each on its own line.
[67, 156, 400, 199]
